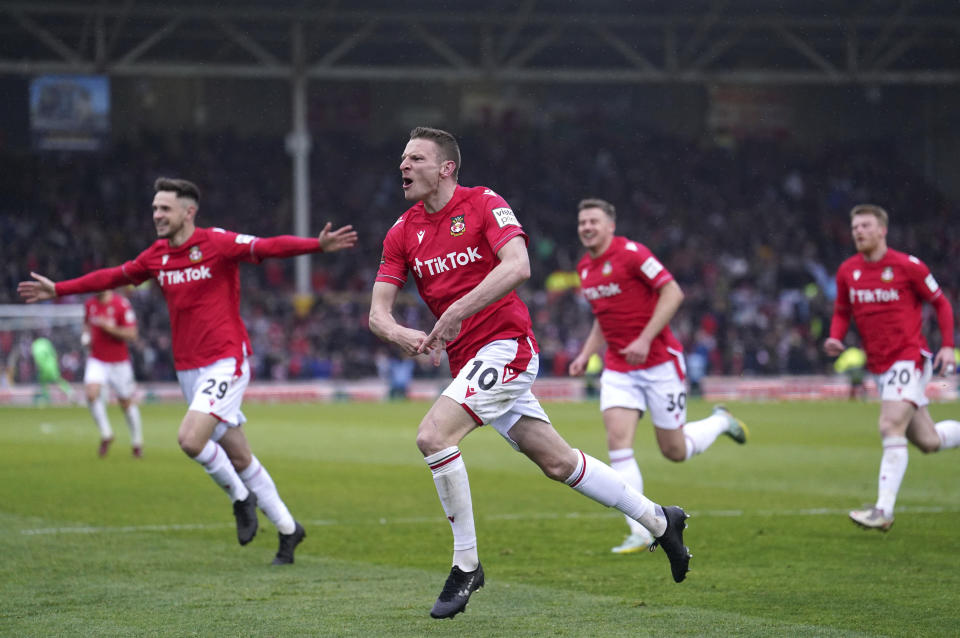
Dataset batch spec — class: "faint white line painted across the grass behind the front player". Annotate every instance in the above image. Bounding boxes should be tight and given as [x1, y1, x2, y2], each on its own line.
[20, 505, 960, 536]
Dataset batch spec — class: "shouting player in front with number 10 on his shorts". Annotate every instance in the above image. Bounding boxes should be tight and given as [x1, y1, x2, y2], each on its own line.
[370, 127, 690, 618]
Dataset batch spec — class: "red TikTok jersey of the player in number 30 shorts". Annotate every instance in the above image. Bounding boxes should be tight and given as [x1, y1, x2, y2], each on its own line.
[577, 236, 683, 372]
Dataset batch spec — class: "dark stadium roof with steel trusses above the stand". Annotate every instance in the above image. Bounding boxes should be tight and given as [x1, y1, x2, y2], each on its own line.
[0, 0, 960, 85]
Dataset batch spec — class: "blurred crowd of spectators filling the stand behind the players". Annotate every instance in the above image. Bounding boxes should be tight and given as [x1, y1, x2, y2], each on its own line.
[0, 112, 960, 388]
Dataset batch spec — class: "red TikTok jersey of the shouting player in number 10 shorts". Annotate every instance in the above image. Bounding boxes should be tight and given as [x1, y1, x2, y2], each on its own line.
[376, 186, 533, 376]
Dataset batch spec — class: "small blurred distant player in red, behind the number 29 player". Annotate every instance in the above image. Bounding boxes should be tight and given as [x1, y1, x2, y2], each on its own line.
[82, 290, 143, 458]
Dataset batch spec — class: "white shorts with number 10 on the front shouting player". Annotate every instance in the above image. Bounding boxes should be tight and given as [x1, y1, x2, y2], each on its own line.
[443, 337, 550, 449]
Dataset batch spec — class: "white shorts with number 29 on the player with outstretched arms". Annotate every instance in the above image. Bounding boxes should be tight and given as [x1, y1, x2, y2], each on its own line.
[177, 357, 250, 441]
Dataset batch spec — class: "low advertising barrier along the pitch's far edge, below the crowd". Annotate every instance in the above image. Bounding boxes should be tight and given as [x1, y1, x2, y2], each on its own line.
[0, 375, 958, 405]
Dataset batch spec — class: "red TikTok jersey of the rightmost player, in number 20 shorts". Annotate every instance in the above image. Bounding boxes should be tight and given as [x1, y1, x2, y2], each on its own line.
[830, 248, 943, 374]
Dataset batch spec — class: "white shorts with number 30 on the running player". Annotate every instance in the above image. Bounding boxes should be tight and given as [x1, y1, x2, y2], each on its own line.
[600, 355, 687, 430]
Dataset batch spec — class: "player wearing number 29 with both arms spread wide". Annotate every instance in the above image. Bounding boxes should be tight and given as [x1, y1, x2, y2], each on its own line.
[17, 177, 357, 565]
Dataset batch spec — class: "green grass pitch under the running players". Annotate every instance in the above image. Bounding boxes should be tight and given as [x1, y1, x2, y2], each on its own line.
[0, 402, 960, 638]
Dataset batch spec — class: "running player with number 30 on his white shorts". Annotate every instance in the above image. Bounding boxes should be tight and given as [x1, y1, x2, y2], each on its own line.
[569, 199, 747, 554]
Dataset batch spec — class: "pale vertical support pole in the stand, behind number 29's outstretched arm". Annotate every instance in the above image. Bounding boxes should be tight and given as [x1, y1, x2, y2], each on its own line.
[287, 22, 312, 299]
